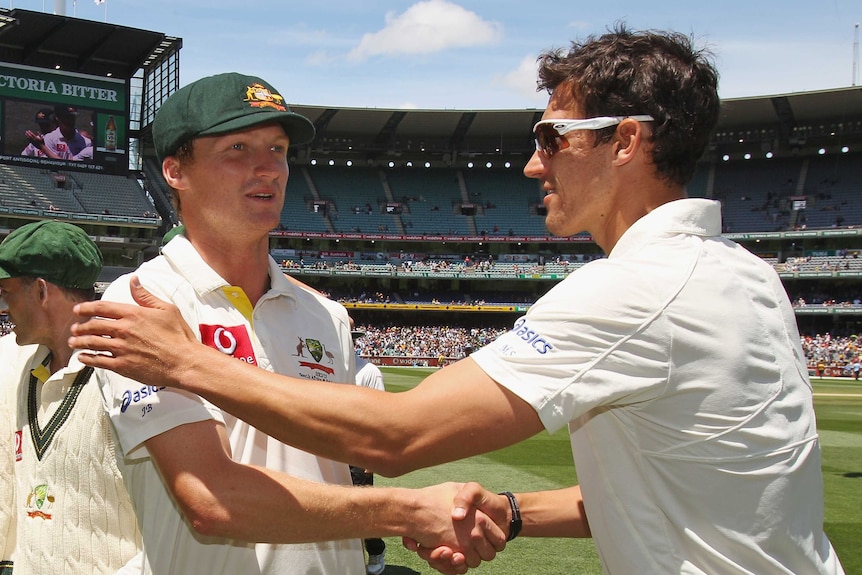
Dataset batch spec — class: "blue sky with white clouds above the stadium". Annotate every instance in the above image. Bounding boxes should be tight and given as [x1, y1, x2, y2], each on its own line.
[11, 0, 862, 109]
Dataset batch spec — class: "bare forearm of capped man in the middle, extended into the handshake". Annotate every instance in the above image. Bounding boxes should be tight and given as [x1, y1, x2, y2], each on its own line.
[178, 463, 490, 549]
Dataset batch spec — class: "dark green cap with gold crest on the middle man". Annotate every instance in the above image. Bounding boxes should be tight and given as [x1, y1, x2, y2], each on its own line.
[153, 72, 314, 161]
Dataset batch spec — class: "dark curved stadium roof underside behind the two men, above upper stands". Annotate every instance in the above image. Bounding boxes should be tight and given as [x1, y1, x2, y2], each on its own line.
[293, 87, 862, 160]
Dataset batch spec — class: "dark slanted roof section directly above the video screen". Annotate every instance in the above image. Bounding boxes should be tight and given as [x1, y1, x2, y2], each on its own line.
[0, 8, 182, 80]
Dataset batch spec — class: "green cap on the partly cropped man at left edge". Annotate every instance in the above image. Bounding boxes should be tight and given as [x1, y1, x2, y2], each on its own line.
[0, 220, 102, 289]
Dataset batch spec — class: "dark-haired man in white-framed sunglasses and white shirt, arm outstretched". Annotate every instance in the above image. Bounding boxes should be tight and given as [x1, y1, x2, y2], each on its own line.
[73, 26, 843, 574]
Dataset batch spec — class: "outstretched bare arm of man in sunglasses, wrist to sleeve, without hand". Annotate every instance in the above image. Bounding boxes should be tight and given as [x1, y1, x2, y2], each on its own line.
[176, 356, 542, 476]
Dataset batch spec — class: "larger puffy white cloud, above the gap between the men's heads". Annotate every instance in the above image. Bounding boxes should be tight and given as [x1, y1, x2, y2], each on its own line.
[348, 0, 502, 60]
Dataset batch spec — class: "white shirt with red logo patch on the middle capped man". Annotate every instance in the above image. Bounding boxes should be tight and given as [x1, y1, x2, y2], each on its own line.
[95, 236, 365, 575]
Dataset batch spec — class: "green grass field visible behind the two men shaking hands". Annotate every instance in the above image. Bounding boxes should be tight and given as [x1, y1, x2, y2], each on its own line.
[375, 368, 862, 575]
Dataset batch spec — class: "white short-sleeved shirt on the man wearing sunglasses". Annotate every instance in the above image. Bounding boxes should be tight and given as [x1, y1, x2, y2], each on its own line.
[472, 199, 843, 574]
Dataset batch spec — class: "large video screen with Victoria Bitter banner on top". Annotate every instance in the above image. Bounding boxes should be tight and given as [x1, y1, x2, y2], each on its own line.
[0, 63, 129, 174]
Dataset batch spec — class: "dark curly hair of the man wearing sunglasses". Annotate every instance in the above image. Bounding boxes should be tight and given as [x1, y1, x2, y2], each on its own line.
[537, 24, 720, 186]
